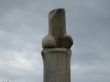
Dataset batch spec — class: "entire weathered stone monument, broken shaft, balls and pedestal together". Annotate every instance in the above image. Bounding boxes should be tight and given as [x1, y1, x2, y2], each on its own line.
[42, 9, 73, 82]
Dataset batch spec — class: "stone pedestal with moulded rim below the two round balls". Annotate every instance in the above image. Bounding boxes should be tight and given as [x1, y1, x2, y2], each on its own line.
[42, 48, 71, 82]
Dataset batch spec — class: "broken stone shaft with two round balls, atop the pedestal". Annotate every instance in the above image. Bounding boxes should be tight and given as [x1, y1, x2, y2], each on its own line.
[42, 9, 73, 48]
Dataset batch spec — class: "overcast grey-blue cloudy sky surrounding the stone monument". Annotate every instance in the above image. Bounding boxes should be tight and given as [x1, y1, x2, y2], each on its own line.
[0, 0, 110, 82]
